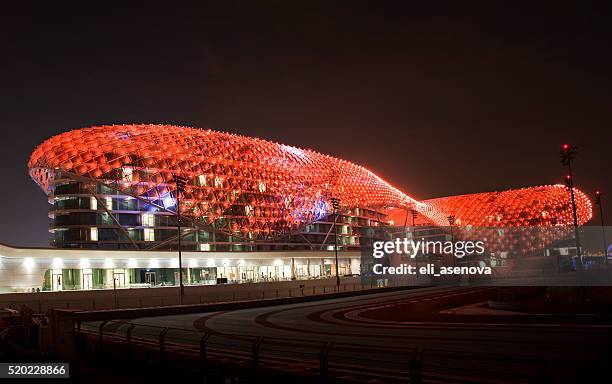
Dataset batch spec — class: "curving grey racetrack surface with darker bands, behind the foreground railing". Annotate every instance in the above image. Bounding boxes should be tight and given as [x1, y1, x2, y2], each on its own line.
[83, 287, 612, 382]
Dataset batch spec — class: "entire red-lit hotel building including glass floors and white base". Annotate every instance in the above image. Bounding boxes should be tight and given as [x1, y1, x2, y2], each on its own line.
[0, 125, 592, 290]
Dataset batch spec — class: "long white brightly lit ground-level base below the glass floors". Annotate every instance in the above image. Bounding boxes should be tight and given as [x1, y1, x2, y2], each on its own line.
[0, 245, 361, 292]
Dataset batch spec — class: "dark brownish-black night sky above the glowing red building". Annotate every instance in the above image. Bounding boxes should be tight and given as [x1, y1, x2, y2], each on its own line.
[0, 1, 612, 246]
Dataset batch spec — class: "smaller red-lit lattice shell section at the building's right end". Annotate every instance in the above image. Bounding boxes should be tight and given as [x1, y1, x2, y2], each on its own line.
[425, 185, 593, 254]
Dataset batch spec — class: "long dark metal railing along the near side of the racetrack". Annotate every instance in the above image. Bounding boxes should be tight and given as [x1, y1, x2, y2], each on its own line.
[75, 320, 552, 383]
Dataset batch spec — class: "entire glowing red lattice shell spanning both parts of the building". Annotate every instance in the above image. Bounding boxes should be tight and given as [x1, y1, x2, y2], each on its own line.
[28, 124, 592, 239]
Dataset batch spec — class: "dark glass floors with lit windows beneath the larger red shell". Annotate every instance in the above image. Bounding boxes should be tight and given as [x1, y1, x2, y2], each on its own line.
[49, 177, 386, 252]
